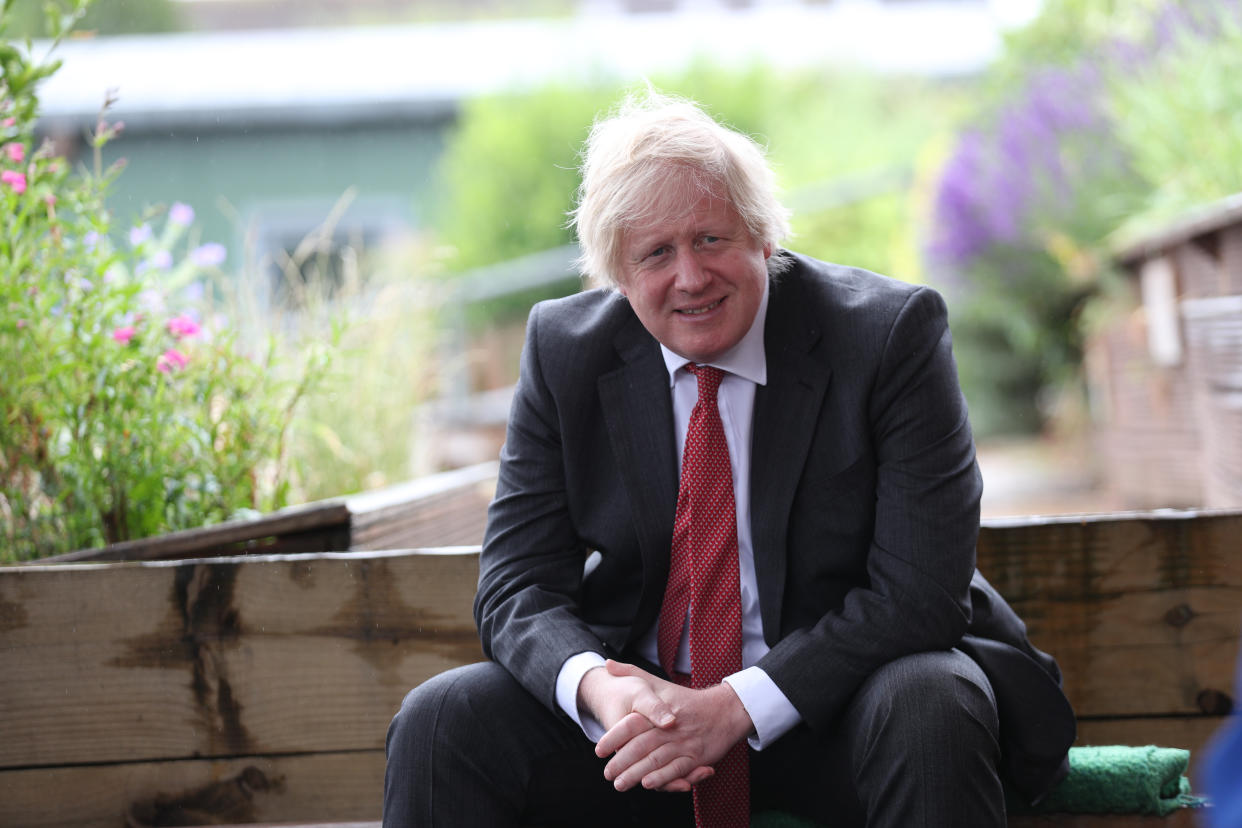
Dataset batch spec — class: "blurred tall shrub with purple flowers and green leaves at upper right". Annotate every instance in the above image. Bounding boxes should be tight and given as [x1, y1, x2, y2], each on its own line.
[928, 0, 1242, 433]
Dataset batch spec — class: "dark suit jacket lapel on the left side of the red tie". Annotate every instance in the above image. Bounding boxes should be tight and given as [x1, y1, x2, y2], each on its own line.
[597, 317, 677, 631]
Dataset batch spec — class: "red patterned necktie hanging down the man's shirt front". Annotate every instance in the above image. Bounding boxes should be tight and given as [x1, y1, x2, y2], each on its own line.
[657, 364, 750, 828]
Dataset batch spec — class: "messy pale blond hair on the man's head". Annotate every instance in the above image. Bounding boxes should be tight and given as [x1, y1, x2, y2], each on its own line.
[570, 87, 790, 287]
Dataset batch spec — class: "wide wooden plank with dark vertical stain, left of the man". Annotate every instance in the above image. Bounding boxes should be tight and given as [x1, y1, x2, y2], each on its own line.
[0, 551, 482, 767]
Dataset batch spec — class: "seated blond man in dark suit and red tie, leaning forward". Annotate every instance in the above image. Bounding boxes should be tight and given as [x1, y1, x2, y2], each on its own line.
[384, 93, 1074, 828]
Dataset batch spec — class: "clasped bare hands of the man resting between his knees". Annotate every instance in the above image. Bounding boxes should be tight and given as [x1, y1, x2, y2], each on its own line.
[579, 660, 753, 792]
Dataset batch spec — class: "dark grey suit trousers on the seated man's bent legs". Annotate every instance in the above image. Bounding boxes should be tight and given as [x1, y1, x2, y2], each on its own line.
[384, 650, 1005, 828]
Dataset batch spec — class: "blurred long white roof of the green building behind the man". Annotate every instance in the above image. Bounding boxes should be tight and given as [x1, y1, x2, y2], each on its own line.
[36, 0, 1001, 129]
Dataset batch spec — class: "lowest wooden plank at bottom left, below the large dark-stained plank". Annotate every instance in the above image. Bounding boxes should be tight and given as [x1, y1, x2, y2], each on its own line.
[0, 750, 384, 828]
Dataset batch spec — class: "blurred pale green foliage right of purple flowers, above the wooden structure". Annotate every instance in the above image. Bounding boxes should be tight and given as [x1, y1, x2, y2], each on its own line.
[1108, 6, 1242, 240]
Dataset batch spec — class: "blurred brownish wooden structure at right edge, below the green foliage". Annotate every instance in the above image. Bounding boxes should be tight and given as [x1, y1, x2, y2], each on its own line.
[1087, 194, 1242, 508]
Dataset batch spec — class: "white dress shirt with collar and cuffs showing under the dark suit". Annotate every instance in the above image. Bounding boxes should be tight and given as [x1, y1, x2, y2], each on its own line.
[556, 284, 801, 750]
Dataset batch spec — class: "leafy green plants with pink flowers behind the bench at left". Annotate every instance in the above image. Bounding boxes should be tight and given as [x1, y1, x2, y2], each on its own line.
[0, 2, 327, 560]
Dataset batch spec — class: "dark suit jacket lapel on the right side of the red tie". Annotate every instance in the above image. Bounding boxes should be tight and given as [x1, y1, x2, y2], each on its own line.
[750, 266, 831, 646]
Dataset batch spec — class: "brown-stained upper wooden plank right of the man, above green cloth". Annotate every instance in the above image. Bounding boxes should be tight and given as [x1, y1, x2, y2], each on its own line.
[979, 511, 1242, 716]
